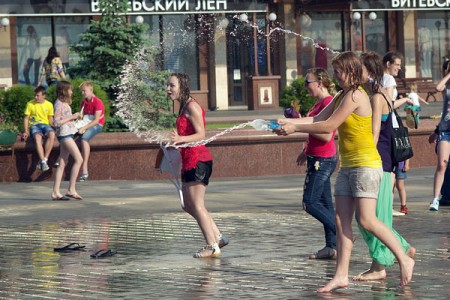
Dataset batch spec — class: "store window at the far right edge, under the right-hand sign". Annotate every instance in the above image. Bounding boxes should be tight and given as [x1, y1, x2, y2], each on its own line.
[417, 11, 450, 80]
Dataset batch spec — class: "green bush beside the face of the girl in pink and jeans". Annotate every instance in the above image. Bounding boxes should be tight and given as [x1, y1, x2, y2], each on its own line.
[280, 77, 316, 117]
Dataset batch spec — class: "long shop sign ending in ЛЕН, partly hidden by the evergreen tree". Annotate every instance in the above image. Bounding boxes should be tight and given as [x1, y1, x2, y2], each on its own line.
[0, 0, 267, 16]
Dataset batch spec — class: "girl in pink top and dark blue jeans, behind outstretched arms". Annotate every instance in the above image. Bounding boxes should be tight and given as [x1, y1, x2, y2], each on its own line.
[284, 68, 337, 259]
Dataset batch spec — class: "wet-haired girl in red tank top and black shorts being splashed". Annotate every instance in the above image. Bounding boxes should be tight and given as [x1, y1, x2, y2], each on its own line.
[166, 73, 229, 258]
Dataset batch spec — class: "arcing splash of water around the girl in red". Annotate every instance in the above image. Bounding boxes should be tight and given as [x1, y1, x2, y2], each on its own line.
[116, 15, 339, 148]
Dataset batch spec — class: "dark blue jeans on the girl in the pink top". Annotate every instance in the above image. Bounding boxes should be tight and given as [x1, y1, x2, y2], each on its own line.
[303, 156, 337, 249]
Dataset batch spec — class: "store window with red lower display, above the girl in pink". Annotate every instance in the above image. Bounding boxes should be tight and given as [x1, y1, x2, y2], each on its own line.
[300, 12, 347, 72]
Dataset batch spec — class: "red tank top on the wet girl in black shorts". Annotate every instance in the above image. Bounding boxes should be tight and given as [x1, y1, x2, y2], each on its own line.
[176, 98, 212, 171]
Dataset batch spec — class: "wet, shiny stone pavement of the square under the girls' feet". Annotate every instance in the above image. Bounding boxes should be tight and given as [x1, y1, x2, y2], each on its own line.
[0, 168, 450, 299]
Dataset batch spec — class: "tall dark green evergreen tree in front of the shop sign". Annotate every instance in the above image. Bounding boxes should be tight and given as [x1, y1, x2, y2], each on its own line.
[69, 0, 148, 94]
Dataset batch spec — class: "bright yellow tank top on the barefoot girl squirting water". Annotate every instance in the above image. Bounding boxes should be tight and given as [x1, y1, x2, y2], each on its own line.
[334, 87, 381, 168]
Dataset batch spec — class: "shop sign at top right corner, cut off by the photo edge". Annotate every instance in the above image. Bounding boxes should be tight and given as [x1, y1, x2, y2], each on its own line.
[352, 0, 450, 11]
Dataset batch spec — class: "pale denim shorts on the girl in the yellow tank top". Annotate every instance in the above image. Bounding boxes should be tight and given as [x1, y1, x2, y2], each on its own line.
[334, 167, 383, 199]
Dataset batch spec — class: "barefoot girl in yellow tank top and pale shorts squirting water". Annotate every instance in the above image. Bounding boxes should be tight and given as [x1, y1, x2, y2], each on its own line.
[277, 52, 414, 293]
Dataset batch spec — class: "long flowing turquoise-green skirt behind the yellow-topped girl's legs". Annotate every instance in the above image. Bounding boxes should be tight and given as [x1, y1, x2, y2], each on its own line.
[358, 172, 410, 266]
